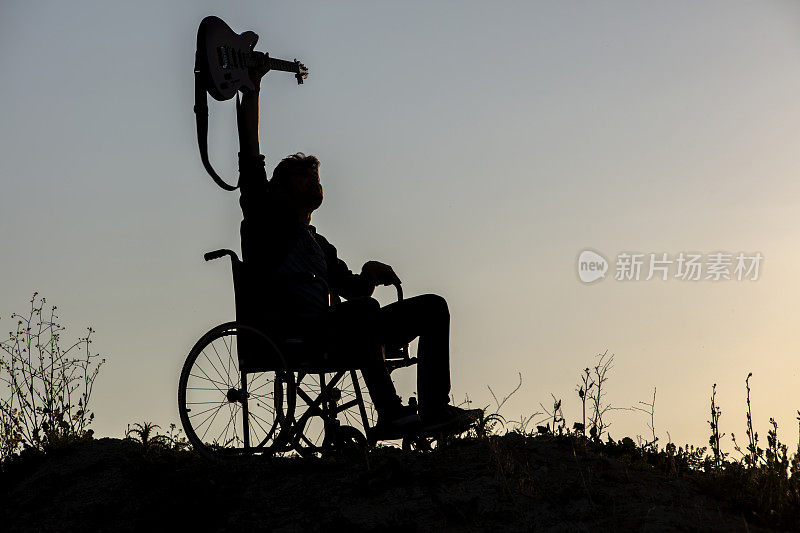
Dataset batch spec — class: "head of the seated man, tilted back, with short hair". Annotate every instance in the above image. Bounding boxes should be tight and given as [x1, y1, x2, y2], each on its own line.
[269, 152, 322, 215]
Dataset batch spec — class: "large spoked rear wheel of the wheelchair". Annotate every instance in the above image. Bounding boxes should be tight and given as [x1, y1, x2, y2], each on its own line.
[178, 322, 295, 458]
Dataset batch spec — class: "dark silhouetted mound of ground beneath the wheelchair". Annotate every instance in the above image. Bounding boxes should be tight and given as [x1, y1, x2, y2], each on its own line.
[0, 435, 788, 531]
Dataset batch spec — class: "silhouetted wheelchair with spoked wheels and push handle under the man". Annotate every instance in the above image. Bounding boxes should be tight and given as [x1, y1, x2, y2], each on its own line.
[178, 249, 417, 459]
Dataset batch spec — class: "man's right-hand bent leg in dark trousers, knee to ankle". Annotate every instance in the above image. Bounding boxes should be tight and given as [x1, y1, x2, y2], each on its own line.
[377, 294, 450, 412]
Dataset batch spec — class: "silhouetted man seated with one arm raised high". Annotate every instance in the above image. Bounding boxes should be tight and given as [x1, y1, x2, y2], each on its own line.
[237, 63, 480, 439]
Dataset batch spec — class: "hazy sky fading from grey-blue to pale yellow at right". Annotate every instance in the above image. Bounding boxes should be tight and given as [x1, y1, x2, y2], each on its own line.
[0, 0, 800, 449]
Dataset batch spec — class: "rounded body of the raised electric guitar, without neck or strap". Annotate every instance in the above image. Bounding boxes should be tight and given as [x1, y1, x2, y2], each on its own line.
[195, 16, 263, 101]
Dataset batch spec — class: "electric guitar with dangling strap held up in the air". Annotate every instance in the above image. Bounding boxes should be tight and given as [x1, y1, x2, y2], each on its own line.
[194, 16, 308, 191]
